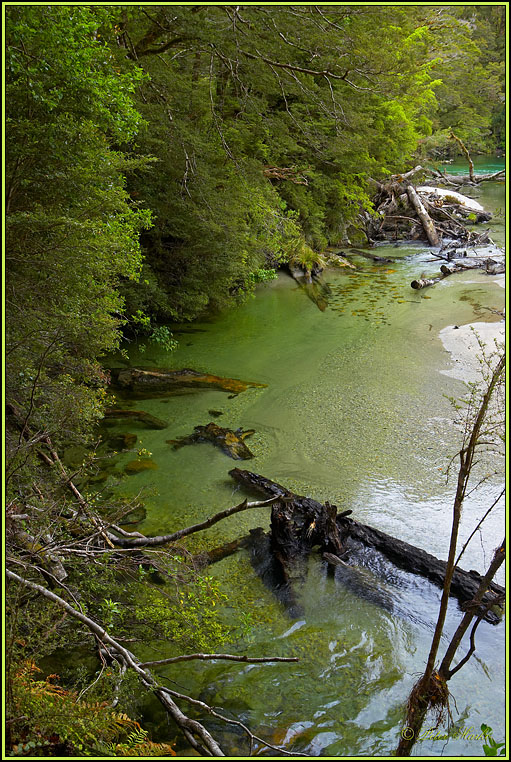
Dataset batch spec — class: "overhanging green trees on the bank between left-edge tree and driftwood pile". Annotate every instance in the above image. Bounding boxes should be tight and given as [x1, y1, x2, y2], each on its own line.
[121, 6, 460, 320]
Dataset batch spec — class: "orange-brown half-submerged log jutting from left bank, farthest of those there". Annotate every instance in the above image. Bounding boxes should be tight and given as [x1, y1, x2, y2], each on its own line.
[117, 368, 266, 394]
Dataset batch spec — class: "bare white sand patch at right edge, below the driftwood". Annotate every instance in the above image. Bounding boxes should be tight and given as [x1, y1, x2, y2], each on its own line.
[440, 320, 506, 381]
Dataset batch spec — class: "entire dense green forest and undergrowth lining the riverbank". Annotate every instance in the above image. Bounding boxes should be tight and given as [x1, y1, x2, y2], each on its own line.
[4, 3, 506, 756]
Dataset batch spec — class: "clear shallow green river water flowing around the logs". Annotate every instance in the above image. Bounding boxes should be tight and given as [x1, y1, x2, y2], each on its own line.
[101, 162, 505, 756]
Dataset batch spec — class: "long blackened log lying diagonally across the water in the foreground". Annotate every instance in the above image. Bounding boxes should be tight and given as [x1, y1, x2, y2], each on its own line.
[229, 468, 505, 624]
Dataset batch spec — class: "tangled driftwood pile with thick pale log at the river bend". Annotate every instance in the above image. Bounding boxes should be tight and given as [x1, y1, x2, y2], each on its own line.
[364, 166, 492, 247]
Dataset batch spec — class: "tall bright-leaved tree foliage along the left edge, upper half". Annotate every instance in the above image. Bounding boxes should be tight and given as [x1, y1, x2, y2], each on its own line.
[6, 6, 150, 452]
